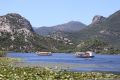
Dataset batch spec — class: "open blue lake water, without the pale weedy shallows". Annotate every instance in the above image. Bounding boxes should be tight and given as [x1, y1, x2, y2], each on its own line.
[7, 53, 120, 72]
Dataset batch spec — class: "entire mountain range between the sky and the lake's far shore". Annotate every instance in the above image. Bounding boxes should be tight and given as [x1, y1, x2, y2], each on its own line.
[0, 10, 120, 52]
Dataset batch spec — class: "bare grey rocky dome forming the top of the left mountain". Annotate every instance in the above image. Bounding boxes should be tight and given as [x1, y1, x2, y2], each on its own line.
[0, 13, 33, 36]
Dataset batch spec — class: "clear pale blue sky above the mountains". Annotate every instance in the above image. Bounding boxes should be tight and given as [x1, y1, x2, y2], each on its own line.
[0, 0, 120, 27]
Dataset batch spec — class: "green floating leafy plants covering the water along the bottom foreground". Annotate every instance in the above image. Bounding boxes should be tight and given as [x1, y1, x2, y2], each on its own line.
[0, 58, 120, 80]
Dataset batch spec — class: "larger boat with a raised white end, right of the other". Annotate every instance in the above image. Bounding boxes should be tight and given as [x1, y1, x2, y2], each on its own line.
[75, 51, 95, 58]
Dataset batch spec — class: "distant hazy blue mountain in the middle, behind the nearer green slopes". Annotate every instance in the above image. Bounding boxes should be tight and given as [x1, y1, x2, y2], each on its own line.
[34, 21, 86, 36]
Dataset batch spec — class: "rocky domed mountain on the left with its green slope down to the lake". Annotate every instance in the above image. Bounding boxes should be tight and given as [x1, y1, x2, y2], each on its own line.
[0, 13, 72, 52]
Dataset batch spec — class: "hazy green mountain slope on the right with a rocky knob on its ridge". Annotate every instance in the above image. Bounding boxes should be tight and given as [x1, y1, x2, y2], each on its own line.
[71, 10, 120, 48]
